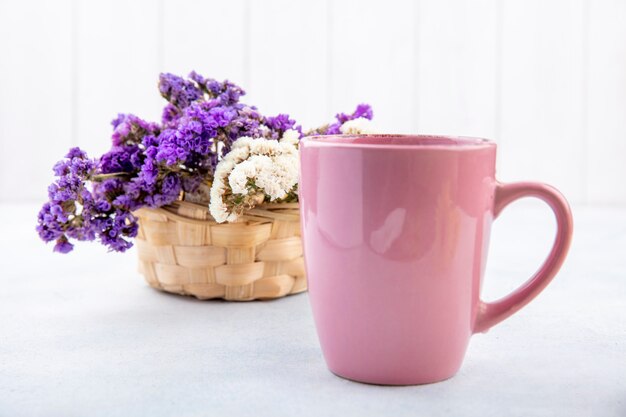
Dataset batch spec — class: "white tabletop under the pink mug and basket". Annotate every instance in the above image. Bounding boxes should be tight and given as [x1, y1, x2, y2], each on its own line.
[0, 203, 626, 417]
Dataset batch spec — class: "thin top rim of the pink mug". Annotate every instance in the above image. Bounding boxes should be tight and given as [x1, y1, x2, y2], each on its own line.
[301, 133, 496, 151]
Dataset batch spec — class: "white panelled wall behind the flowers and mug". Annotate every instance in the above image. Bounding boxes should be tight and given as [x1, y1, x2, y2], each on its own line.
[0, 0, 626, 204]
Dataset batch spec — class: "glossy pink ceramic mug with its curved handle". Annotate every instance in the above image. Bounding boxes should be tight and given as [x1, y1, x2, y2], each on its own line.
[299, 135, 572, 385]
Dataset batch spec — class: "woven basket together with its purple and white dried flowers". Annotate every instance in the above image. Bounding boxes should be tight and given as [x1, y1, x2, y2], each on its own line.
[37, 72, 372, 300]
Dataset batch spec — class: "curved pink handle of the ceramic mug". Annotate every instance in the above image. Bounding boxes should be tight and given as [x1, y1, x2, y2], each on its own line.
[474, 182, 573, 333]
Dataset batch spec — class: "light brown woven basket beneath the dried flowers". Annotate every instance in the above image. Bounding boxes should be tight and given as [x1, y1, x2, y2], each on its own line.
[135, 201, 307, 301]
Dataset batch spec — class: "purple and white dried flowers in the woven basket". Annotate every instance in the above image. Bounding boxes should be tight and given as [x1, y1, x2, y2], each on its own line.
[37, 72, 372, 253]
